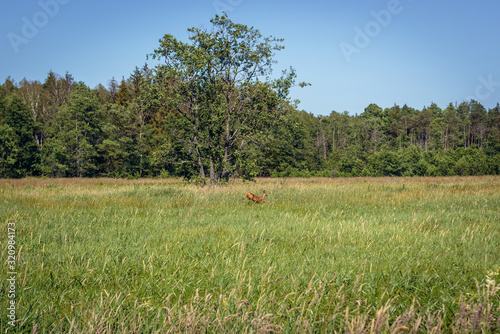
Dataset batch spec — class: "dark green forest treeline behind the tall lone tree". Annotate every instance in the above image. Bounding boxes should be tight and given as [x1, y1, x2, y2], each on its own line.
[0, 75, 500, 180]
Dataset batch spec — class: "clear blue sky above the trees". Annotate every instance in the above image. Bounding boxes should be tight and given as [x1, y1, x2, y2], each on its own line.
[0, 0, 500, 115]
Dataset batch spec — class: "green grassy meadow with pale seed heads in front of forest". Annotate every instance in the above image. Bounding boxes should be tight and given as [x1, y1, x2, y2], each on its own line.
[0, 176, 500, 333]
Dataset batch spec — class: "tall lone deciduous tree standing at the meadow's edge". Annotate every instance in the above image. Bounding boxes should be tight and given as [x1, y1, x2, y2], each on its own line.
[149, 15, 305, 184]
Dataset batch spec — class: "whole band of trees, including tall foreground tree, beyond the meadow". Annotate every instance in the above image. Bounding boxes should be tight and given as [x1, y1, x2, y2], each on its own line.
[0, 15, 500, 184]
